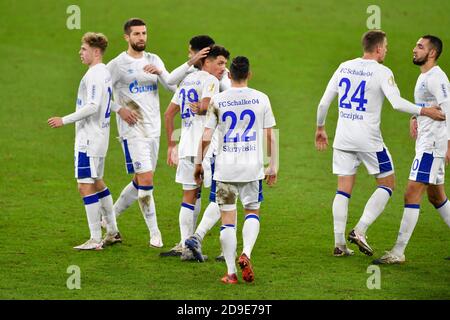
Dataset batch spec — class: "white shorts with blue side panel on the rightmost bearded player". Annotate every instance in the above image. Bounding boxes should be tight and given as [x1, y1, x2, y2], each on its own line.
[409, 152, 445, 185]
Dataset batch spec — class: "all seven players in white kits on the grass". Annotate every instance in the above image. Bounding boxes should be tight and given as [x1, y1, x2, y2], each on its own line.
[48, 18, 450, 284]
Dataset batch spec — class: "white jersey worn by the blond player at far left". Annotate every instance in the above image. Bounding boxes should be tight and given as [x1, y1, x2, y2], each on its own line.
[75, 63, 112, 157]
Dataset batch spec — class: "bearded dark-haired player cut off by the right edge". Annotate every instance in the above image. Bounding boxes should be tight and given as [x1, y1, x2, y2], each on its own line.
[374, 35, 450, 264]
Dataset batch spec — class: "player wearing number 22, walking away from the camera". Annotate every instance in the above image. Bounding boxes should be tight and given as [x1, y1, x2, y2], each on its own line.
[195, 57, 277, 284]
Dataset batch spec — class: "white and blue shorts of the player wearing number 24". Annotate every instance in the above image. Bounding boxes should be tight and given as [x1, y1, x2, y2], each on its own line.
[333, 145, 394, 178]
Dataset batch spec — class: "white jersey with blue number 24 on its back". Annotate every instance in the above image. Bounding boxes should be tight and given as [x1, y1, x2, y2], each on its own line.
[327, 58, 400, 152]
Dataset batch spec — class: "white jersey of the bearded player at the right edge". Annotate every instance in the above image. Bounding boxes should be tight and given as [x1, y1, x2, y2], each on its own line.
[414, 66, 450, 157]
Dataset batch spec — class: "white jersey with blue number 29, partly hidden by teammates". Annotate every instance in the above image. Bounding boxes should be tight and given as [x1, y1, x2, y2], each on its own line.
[172, 71, 219, 159]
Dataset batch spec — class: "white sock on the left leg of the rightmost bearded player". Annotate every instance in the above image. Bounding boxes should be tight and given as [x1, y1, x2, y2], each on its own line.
[392, 204, 420, 257]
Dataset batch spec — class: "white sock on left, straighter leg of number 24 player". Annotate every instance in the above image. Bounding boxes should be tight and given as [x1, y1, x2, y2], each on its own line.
[333, 190, 351, 247]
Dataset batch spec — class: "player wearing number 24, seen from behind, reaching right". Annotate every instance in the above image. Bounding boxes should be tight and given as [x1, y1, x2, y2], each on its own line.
[315, 30, 445, 257]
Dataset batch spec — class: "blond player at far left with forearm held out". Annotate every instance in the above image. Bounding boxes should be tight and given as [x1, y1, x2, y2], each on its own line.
[48, 32, 121, 250]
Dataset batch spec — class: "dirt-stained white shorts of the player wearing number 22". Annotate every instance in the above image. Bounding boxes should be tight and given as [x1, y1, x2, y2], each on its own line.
[215, 180, 264, 211]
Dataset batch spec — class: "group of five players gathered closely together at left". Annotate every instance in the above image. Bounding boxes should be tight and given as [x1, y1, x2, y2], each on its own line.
[48, 18, 278, 284]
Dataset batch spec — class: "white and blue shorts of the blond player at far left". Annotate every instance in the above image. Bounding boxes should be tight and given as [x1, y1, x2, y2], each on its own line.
[75, 152, 105, 183]
